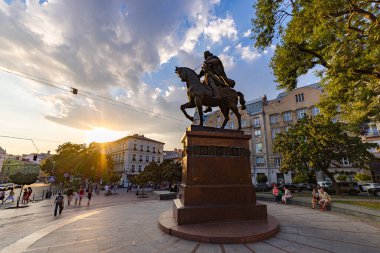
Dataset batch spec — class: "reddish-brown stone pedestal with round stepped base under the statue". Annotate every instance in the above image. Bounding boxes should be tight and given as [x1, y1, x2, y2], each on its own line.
[159, 126, 279, 243]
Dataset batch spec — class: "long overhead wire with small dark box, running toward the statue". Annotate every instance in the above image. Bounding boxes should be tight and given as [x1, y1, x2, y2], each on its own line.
[0, 65, 188, 125]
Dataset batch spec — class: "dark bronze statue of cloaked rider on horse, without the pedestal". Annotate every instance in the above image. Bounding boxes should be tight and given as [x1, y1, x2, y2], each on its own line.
[175, 51, 246, 130]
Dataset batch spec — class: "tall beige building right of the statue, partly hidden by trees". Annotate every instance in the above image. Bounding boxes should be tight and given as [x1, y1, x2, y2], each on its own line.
[203, 84, 372, 184]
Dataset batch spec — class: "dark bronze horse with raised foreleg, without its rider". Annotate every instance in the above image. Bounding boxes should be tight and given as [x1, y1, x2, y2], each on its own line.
[175, 67, 246, 130]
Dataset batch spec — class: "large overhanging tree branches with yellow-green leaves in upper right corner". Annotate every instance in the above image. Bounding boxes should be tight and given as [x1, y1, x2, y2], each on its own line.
[252, 0, 380, 126]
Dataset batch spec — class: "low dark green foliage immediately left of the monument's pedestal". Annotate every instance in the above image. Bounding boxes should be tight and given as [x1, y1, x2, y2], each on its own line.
[133, 160, 182, 185]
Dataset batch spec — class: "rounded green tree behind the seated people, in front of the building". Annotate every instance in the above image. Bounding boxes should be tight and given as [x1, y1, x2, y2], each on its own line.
[274, 116, 377, 194]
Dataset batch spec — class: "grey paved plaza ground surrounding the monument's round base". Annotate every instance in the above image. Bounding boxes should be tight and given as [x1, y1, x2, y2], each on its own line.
[3, 200, 380, 253]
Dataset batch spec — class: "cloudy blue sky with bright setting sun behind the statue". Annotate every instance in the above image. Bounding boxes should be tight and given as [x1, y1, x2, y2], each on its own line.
[0, 0, 317, 154]
